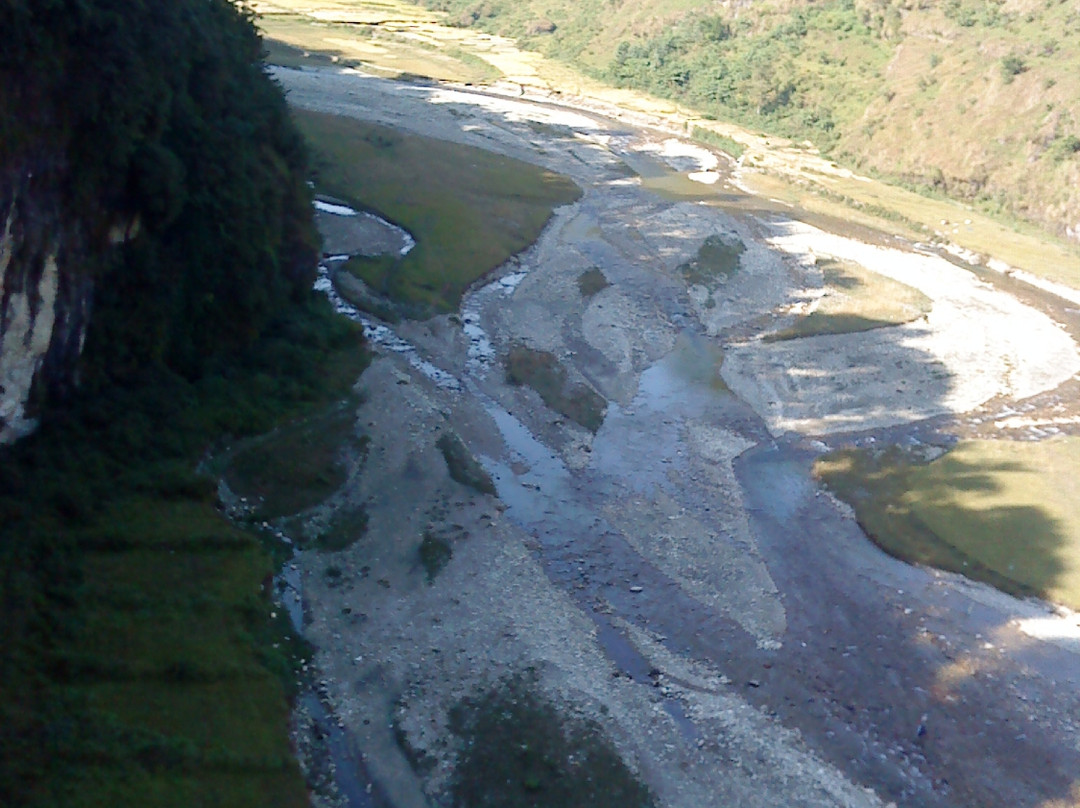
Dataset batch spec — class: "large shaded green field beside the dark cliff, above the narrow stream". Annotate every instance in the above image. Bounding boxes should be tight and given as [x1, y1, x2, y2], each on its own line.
[294, 109, 581, 317]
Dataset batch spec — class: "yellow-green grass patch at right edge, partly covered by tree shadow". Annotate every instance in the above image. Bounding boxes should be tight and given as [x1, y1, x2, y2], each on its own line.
[814, 437, 1080, 609]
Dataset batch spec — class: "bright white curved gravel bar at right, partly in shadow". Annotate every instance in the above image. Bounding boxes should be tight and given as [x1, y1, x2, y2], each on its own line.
[724, 223, 1080, 434]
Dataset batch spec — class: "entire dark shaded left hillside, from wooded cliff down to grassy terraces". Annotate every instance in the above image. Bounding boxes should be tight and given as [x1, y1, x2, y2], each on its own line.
[0, 0, 365, 808]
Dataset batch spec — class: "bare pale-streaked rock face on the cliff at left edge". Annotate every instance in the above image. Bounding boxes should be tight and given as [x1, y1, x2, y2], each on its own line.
[0, 172, 93, 443]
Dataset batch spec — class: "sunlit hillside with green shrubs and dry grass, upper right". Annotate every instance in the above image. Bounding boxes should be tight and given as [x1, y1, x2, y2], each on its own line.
[427, 0, 1080, 241]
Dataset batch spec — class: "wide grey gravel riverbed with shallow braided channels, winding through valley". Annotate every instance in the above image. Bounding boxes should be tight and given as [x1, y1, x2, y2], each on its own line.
[276, 70, 1080, 808]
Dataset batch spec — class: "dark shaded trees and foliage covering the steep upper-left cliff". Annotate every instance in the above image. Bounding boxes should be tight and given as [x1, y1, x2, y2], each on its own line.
[0, 0, 318, 381]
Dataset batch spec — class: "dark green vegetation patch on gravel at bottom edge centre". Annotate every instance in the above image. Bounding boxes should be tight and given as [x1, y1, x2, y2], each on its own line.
[450, 677, 656, 808]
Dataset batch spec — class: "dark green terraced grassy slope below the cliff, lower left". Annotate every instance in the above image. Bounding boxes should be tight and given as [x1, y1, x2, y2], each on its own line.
[0, 296, 367, 808]
